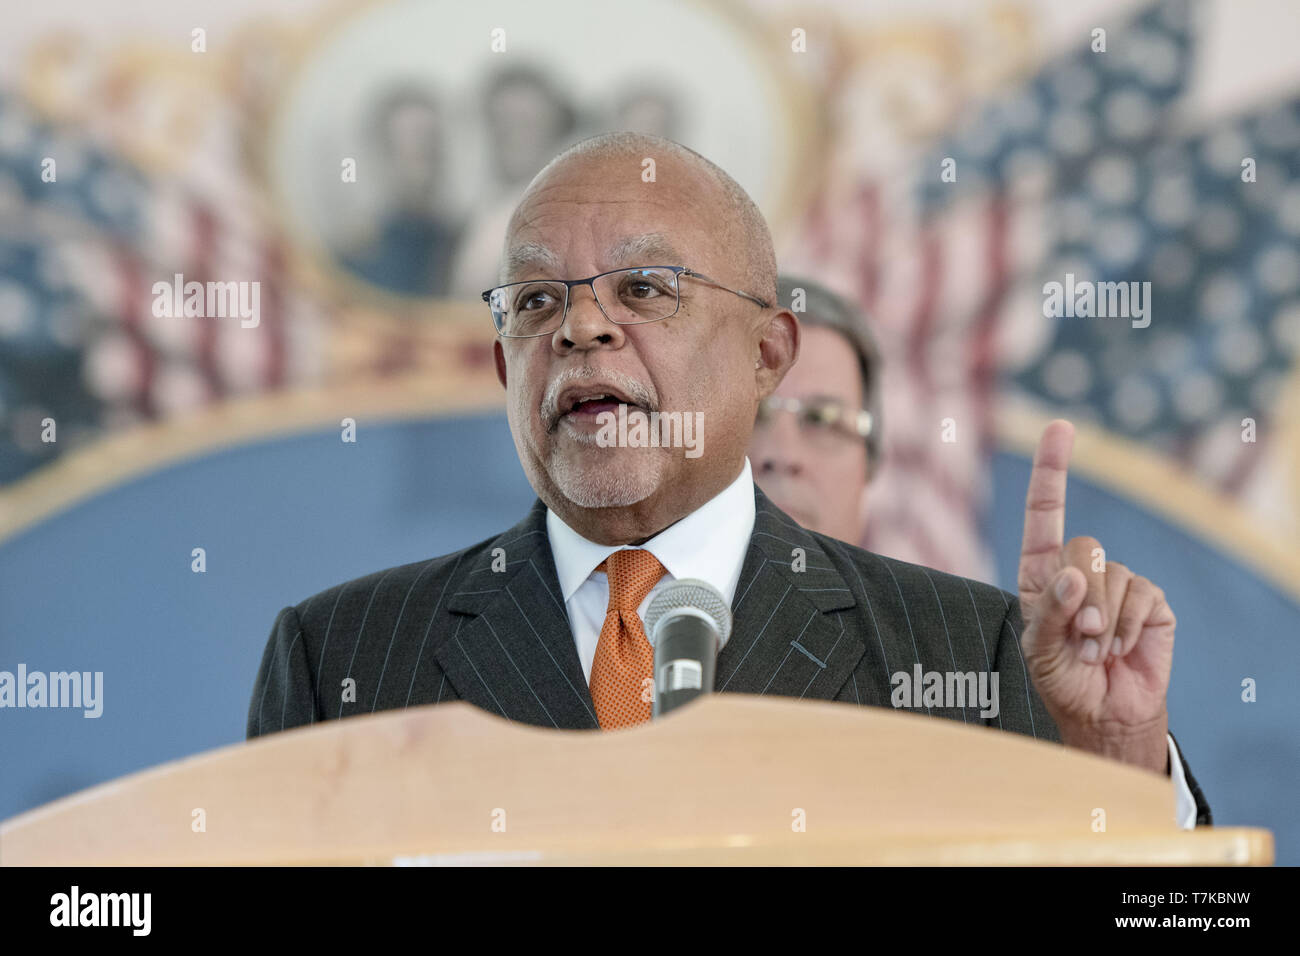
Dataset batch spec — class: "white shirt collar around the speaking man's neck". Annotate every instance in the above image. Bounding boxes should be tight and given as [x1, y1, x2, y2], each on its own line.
[546, 458, 754, 604]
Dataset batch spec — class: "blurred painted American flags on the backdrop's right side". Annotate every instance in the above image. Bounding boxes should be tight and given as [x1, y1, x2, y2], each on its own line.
[794, 0, 1300, 580]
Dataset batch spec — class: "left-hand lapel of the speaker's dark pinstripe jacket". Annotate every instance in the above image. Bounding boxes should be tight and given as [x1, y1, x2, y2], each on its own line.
[434, 501, 599, 730]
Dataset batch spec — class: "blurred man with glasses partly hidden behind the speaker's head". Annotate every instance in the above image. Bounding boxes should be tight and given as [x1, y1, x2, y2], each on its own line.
[749, 276, 880, 544]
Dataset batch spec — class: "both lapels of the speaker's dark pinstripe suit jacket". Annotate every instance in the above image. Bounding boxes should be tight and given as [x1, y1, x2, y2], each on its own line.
[434, 486, 865, 730]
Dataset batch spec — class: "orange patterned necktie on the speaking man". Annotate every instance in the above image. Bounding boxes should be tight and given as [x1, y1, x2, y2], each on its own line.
[592, 548, 664, 730]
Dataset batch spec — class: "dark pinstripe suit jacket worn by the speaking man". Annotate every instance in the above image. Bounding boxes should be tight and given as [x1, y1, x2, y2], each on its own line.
[247, 486, 1210, 823]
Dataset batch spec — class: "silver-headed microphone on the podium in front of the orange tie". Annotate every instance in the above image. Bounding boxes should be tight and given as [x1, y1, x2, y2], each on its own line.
[646, 578, 731, 717]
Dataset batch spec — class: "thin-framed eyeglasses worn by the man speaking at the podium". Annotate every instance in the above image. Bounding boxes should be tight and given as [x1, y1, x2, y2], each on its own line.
[482, 265, 771, 338]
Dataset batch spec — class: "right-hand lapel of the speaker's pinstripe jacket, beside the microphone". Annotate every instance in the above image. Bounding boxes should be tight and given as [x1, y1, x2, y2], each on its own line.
[715, 486, 865, 700]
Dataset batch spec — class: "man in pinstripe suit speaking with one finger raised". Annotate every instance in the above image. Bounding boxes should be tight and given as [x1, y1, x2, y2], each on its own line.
[248, 133, 1210, 826]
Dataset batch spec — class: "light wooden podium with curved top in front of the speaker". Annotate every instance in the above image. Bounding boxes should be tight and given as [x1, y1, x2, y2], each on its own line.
[0, 693, 1273, 865]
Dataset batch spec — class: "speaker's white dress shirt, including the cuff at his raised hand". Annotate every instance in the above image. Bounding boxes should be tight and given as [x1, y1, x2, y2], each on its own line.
[546, 458, 1196, 830]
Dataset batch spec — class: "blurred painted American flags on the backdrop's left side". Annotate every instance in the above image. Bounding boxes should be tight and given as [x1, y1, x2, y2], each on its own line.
[0, 89, 321, 484]
